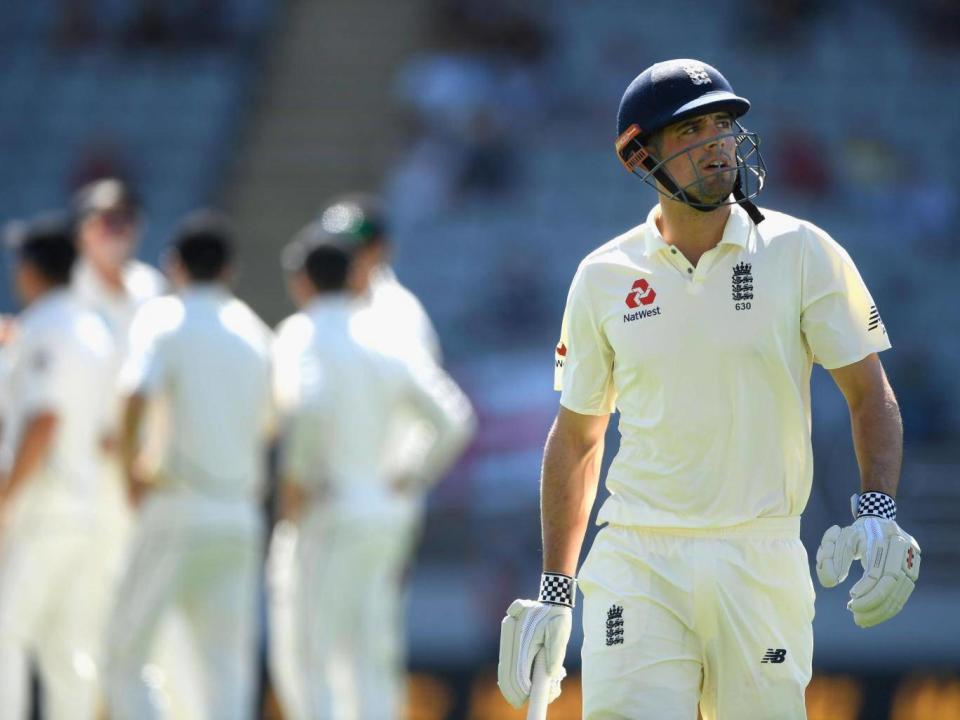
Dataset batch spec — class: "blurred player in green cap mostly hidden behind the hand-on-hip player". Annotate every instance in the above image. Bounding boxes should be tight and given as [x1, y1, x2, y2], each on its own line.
[268, 193, 442, 708]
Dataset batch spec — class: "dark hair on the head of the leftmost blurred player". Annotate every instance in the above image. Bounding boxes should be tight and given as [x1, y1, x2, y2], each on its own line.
[7, 212, 77, 285]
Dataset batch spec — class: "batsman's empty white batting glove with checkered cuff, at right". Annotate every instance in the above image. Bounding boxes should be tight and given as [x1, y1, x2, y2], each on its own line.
[817, 492, 920, 628]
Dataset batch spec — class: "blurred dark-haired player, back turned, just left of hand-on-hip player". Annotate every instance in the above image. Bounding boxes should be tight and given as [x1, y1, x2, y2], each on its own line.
[105, 212, 272, 720]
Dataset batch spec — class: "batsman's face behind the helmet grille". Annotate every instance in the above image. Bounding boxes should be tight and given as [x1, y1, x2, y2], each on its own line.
[654, 112, 737, 205]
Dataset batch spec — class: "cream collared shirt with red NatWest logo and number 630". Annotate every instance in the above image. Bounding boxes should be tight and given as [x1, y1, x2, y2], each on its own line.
[555, 205, 890, 527]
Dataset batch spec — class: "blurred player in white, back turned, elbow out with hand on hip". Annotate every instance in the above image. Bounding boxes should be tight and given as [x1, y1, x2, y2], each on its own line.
[275, 223, 474, 720]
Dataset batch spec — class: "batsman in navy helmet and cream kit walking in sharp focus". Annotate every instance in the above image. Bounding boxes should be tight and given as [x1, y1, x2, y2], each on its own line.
[498, 60, 920, 720]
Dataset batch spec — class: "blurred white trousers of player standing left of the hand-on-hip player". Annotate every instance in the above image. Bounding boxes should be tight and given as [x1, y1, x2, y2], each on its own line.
[104, 494, 262, 720]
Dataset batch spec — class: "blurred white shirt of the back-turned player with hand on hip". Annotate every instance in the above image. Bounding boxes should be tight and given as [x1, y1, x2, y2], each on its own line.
[275, 295, 472, 516]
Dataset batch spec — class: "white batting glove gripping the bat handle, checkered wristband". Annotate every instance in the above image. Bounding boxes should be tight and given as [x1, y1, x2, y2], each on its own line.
[497, 573, 576, 708]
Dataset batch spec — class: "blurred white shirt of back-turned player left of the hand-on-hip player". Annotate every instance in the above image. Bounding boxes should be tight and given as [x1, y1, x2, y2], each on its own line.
[122, 285, 272, 500]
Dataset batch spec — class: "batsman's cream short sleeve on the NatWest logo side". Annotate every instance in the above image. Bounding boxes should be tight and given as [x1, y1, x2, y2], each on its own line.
[554, 266, 616, 415]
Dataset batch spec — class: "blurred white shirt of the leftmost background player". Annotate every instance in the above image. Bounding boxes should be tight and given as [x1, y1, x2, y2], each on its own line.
[0, 289, 116, 519]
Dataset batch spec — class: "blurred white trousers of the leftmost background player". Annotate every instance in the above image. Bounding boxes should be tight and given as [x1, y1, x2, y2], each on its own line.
[0, 518, 101, 720]
